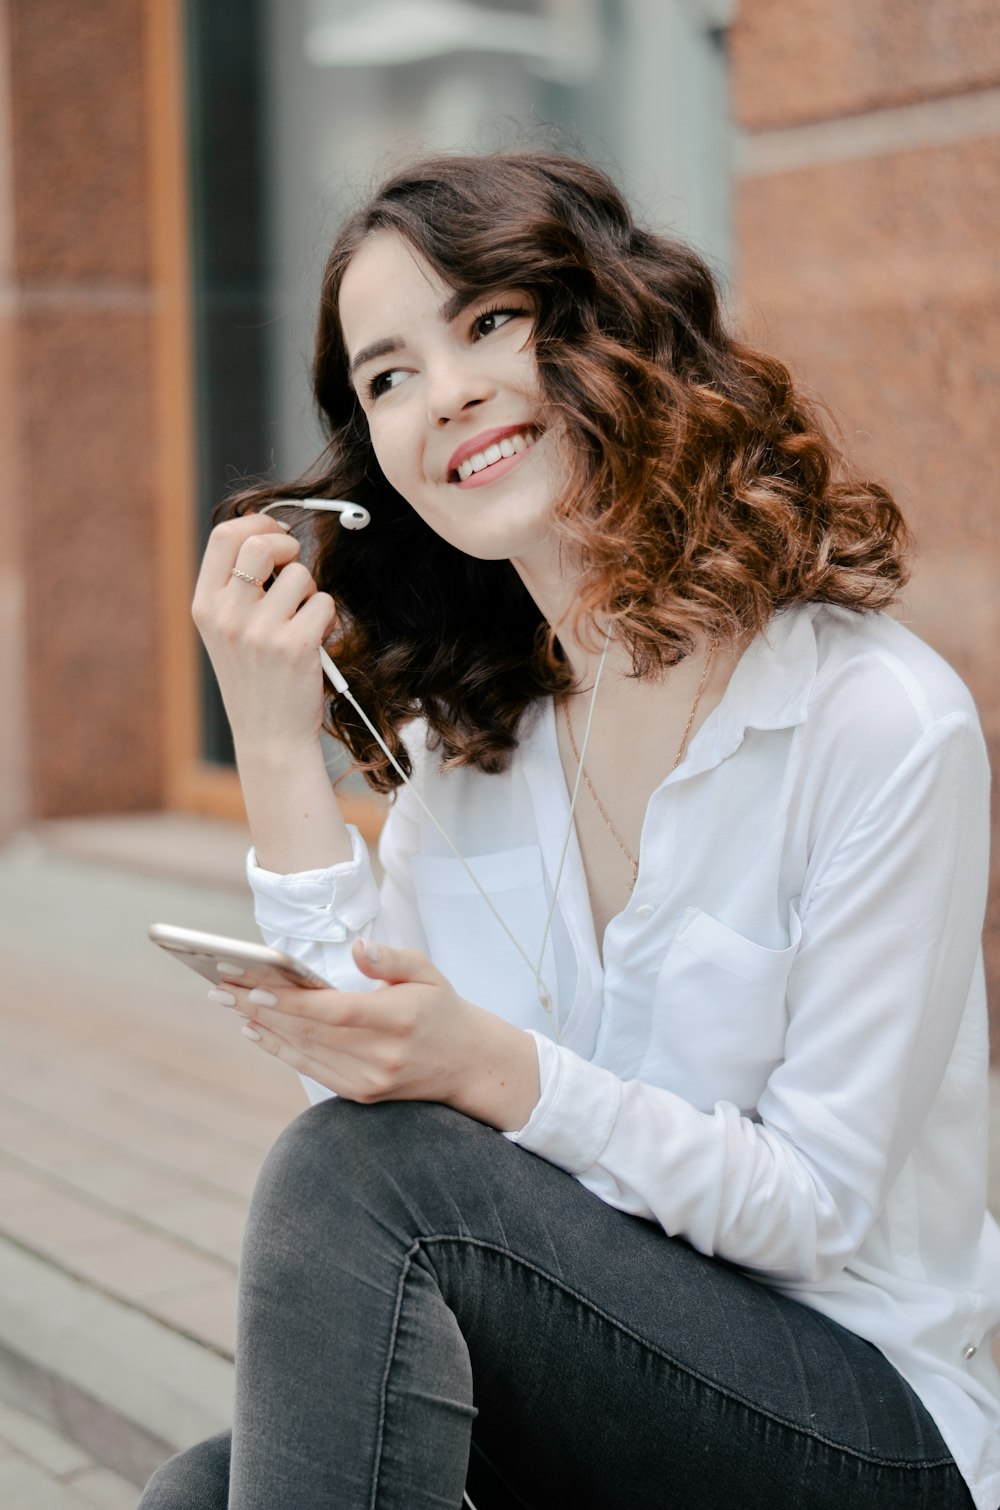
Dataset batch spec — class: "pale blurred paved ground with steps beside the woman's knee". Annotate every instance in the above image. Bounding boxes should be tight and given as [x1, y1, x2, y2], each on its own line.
[0, 817, 1000, 1510]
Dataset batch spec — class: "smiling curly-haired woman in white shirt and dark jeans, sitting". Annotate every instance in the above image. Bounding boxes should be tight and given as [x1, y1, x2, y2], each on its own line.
[144, 156, 1000, 1510]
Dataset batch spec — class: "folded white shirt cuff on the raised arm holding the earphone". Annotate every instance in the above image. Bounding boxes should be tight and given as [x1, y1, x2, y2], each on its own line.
[246, 824, 379, 942]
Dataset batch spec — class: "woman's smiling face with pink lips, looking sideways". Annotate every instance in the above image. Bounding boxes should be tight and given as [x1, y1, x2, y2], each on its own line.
[340, 231, 559, 560]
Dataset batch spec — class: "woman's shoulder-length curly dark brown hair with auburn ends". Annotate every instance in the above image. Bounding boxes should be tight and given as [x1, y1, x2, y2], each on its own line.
[219, 153, 906, 791]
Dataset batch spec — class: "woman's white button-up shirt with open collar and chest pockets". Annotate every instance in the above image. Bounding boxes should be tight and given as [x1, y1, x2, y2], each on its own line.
[249, 606, 1000, 1510]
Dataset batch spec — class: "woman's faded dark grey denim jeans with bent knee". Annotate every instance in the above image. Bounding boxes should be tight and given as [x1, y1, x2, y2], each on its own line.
[140, 1101, 971, 1510]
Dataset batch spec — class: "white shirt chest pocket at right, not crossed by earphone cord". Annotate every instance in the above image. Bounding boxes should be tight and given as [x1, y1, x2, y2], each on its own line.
[639, 908, 802, 1113]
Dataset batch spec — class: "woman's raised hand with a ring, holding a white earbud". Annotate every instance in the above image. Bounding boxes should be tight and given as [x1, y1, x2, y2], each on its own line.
[192, 515, 335, 757]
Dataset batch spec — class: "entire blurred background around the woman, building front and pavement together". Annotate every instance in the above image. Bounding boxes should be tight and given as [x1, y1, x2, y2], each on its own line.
[0, 0, 1000, 1507]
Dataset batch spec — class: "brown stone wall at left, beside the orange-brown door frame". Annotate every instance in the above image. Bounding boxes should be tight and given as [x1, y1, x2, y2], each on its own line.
[3, 0, 162, 817]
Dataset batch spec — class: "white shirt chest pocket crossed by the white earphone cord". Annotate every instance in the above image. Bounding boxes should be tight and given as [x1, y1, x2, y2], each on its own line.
[411, 846, 556, 1033]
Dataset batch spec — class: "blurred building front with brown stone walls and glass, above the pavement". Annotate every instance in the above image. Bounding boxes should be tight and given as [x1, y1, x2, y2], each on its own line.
[0, 0, 1000, 1001]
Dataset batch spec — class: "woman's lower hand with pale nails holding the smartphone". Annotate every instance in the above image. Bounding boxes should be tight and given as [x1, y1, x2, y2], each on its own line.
[216, 939, 539, 1131]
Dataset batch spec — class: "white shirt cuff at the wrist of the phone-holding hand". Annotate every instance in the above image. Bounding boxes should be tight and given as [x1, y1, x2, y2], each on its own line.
[506, 1030, 621, 1175]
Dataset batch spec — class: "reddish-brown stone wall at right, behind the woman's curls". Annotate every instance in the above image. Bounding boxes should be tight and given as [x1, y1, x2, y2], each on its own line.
[731, 0, 1000, 1054]
